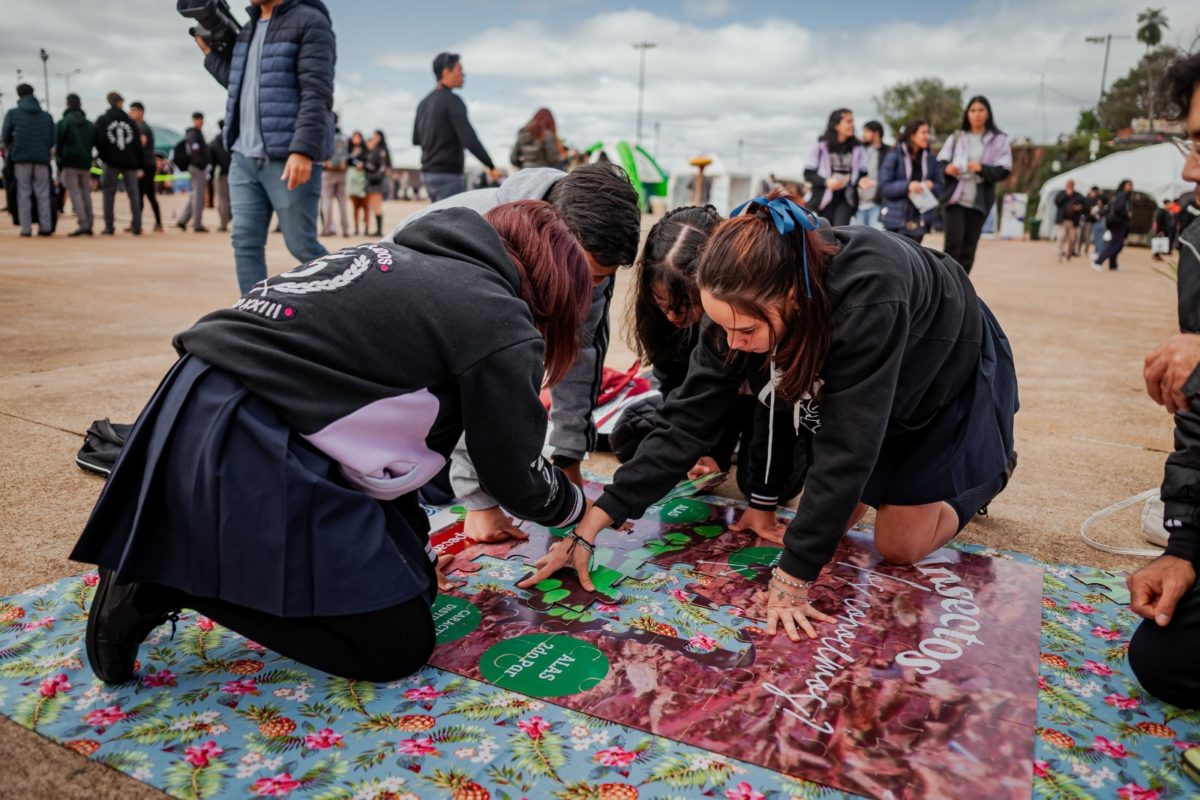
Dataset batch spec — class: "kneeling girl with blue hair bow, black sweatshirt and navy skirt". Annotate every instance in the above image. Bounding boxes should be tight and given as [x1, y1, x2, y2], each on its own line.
[522, 190, 1018, 640]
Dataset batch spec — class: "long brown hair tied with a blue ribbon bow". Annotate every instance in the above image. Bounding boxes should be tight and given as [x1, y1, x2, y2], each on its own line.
[697, 188, 838, 402]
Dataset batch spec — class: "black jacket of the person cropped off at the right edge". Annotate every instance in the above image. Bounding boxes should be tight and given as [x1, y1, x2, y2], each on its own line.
[1160, 212, 1200, 566]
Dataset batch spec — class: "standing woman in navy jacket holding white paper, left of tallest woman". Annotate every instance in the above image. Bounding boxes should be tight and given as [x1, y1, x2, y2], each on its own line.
[880, 120, 942, 243]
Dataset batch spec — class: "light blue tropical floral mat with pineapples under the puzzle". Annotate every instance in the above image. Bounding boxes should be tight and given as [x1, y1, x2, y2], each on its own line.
[0, 527, 1200, 800]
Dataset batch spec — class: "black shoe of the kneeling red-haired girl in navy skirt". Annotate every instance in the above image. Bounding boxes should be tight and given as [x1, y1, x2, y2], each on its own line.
[85, 567, 178, 684]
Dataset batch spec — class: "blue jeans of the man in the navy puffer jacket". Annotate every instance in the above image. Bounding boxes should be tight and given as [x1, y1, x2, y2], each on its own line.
[229, 152, 329, 294]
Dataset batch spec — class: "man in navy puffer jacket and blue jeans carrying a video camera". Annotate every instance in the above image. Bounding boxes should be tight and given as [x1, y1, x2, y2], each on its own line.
[196, 0, 336, 294]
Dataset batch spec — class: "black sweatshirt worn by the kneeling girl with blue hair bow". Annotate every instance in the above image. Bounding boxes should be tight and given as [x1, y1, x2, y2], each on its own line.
[596, 227, 983, 579]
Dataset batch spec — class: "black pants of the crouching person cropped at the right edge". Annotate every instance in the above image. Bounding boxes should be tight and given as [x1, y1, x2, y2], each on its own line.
[1129, 584, 1200, 709]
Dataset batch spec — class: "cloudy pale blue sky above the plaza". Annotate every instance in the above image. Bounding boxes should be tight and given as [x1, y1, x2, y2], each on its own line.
[0, 0, 1200, 170]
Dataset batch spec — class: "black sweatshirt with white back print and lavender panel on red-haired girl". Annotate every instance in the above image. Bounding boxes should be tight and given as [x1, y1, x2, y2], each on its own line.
[175, 209, 583, 527]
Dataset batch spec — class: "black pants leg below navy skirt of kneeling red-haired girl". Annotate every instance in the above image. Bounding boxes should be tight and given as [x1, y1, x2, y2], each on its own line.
[147, 584, 434, 682]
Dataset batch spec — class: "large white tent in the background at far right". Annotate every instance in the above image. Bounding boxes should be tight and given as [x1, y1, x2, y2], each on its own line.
[1038, 142, 1195, 236]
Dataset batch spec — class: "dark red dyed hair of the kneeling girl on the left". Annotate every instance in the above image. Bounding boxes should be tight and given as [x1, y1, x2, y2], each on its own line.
[484, 200, 592, 386]
